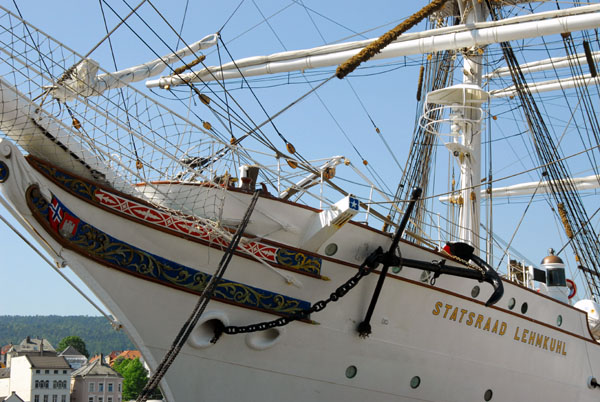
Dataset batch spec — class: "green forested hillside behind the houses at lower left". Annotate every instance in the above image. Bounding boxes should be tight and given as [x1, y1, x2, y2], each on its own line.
[0, 315, 134, 356]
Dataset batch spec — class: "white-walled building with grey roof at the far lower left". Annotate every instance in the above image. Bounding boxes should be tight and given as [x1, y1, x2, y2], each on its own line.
[8, 355, 72, 402]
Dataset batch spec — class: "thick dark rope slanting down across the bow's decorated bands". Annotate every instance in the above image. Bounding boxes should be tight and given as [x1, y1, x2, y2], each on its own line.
[136, 191, 260, 402]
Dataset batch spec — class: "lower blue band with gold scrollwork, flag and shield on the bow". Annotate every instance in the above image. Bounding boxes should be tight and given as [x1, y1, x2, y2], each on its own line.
[27, 186, 310, 315]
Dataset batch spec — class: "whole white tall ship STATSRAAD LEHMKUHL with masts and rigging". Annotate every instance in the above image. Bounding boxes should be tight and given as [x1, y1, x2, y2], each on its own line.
[0, 0, 600, 402]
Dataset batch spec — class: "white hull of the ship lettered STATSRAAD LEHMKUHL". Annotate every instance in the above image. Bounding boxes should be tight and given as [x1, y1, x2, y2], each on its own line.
[0, 140, 600, 402]
